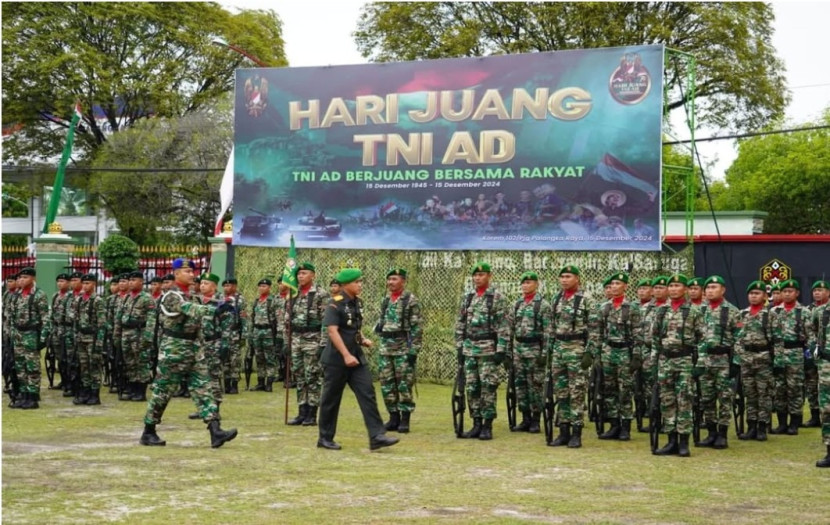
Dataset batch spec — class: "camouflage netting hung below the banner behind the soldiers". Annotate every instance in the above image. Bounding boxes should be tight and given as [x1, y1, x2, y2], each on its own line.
[235, 246, 694, 383]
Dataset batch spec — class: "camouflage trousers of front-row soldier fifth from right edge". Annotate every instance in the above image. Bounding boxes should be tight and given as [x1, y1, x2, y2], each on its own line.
[657, 357, 694, 435]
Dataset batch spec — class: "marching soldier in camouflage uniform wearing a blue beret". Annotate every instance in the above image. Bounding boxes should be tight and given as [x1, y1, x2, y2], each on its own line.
[139, 259, 237, 448]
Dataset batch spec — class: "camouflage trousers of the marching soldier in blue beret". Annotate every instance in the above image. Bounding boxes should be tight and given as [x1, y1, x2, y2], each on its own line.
[144, 335, 219, 425]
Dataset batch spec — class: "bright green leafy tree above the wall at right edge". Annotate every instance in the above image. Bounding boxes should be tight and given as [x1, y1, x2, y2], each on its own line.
[713, 108, 830, 233]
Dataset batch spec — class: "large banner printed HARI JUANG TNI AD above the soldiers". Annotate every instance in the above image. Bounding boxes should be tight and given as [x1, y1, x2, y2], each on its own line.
[233, 46, 663, 251]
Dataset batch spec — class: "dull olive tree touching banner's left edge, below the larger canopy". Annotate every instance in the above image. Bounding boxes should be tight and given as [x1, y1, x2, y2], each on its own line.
[87, 97, 233, 245]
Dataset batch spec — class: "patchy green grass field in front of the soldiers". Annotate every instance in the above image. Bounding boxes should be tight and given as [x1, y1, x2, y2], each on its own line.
[2, 384, 830, 524]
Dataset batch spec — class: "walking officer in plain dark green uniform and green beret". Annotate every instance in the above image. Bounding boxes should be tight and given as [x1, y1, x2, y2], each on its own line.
[317, 268, 399, 450]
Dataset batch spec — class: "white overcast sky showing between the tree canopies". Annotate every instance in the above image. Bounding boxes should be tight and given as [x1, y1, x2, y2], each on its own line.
[219, 0, 830, 179]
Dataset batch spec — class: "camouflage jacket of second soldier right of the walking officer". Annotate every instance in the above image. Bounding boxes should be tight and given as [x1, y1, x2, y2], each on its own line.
[455, 287, 510, 356]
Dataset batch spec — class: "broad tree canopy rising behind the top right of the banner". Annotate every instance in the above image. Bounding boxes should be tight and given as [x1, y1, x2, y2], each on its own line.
[354, 2, 789, 129]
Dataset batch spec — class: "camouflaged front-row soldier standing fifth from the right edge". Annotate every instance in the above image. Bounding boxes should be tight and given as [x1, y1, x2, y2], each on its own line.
[651, 274, 705, 457]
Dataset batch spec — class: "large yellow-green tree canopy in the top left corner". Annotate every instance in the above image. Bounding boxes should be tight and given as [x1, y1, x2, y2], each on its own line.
[2, 2, 286, 162]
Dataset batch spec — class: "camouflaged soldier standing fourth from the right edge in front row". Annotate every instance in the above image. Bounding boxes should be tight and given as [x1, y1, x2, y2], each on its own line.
[695, 275, 740, 450]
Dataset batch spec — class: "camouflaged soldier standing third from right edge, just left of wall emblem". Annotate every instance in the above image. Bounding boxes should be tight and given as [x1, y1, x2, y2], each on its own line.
[735, 281, 773, 441]
